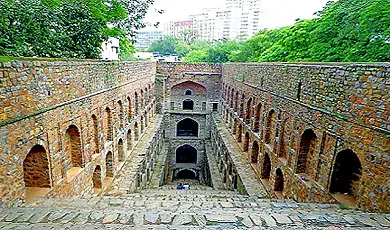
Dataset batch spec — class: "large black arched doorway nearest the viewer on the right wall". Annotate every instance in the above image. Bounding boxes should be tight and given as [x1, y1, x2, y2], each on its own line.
[329, 149, 362, 196]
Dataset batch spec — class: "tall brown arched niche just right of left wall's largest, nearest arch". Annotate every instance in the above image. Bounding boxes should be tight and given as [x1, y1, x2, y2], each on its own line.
[66, 125, 83, 168]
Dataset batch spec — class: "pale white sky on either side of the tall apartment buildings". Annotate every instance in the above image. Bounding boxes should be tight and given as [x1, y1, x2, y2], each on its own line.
[145, 0, 334, 29]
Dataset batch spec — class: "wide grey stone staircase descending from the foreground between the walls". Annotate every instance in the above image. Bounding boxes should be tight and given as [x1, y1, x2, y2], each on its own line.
[0, 184, 390, 229]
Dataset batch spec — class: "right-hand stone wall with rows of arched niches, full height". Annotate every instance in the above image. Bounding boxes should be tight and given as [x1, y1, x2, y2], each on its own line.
[220, 64, 390, 212]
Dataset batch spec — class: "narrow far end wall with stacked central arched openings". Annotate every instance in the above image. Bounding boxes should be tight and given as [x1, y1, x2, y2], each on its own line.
[157, 63, 221, 184]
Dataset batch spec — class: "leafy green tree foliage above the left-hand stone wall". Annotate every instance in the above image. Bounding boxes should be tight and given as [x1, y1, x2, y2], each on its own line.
[0, 0, 153, 58]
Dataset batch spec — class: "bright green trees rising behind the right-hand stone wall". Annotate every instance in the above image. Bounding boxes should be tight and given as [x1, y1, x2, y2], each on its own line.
[154, 0, 390, 62]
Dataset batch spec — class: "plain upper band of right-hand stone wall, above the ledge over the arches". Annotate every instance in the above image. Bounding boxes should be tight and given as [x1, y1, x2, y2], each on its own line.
[223, 63, 390, 131]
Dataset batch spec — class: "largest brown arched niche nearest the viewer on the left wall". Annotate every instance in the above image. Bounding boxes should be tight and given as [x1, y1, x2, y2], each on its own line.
[23, 145, 51, 203]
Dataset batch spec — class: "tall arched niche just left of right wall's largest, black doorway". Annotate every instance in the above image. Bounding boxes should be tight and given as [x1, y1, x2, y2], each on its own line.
[296, 129, 317, 173]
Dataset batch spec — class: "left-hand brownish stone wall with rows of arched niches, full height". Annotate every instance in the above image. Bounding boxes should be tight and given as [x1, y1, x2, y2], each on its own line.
[0, 61, 155, 206]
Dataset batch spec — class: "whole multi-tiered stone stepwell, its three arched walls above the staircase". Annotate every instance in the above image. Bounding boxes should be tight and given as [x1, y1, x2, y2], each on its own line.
[0, 61, 390, 221]
